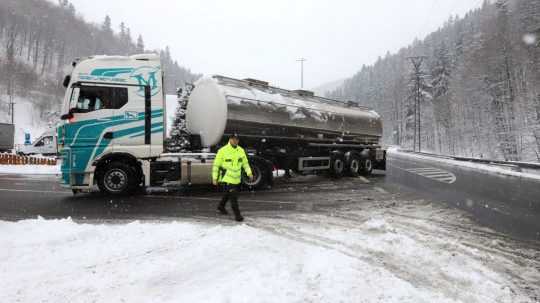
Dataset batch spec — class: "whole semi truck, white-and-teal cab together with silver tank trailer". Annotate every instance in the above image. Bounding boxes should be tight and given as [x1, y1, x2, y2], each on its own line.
[58, 54, 386, 194]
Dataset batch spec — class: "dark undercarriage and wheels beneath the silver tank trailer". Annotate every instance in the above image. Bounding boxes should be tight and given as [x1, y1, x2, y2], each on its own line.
[200, 135, 386, 189]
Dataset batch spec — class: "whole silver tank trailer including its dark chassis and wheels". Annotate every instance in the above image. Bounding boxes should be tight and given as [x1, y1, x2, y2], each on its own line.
[186, 76, 386, 187]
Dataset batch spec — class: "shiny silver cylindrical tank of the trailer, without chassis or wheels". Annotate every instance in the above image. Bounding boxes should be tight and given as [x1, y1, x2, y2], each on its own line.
[186, 76, 382, 147]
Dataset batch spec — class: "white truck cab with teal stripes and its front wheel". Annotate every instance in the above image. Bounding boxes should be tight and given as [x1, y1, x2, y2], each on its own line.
[58, 54, 179, 193]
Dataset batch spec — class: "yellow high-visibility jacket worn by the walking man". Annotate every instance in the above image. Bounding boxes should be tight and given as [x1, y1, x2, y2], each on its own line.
[212, 143, 252, 185]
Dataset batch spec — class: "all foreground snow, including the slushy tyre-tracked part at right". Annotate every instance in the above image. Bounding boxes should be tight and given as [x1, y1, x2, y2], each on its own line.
[0, 211, 534, 302]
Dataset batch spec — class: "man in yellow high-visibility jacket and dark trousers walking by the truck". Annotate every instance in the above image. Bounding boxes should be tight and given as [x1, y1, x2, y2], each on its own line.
[212, 134, 253, 222]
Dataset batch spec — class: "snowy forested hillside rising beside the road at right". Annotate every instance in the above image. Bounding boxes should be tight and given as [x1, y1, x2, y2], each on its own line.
[330, 0, 540, 160]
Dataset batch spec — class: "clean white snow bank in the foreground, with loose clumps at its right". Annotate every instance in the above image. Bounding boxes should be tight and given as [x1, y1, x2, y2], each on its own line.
[0, 219, 532, 302]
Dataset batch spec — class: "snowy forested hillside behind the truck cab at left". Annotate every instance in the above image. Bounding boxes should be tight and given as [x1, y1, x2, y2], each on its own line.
[0, 0, 198, 111]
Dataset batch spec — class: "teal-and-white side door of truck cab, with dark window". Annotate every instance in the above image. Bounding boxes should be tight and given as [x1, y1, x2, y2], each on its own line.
[62, 84, 128, 185]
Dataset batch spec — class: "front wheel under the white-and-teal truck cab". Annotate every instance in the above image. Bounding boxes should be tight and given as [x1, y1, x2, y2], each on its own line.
[97, 162, 138, 195]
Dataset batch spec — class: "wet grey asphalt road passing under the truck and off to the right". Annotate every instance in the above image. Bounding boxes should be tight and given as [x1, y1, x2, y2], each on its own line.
[0, 157, 540, 245]
